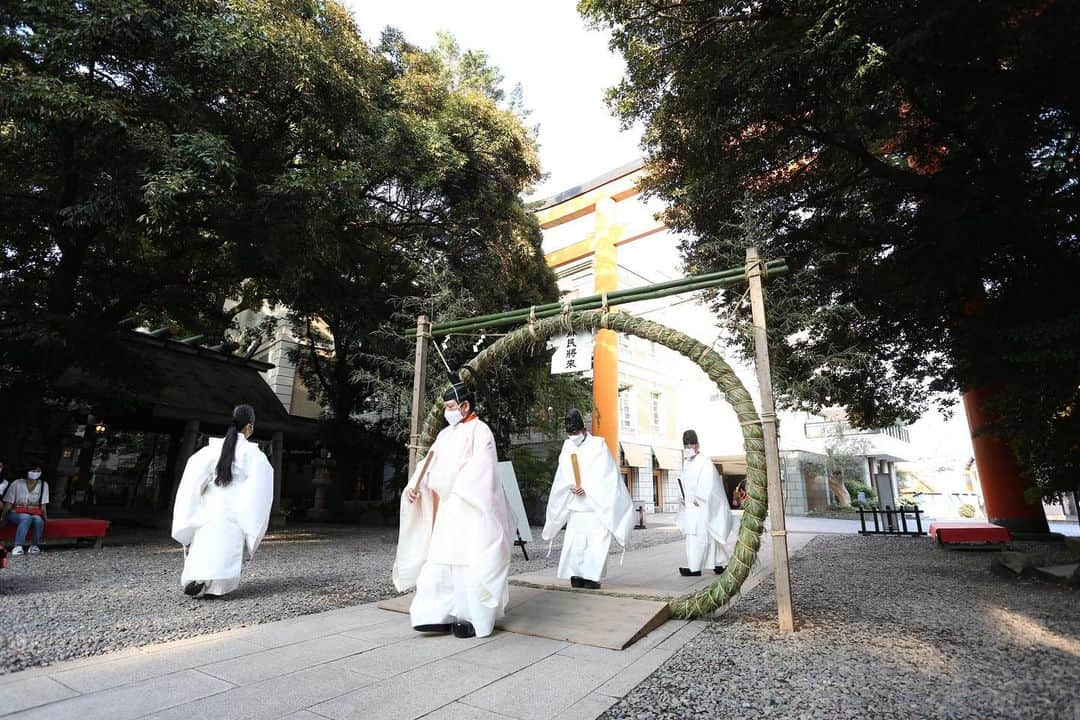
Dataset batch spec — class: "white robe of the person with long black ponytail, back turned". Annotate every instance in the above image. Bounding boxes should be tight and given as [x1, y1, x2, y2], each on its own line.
[173, 435, 273, 595]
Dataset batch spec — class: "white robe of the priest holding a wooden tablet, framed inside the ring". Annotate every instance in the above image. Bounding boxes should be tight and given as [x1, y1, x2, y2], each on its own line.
[543, 435, 634, 582]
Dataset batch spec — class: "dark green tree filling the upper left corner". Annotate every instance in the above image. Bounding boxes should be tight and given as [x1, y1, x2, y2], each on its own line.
[0, 0, 330, 467]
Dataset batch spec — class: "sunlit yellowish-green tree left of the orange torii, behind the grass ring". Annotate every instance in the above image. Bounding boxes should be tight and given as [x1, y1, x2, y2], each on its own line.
[264, 28, 556, 505]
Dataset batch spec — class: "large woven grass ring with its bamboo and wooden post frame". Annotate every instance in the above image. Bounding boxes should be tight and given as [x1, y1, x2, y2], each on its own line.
[406, 248, 794, 630]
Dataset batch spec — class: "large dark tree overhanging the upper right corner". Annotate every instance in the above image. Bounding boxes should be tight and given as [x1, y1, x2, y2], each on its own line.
[579, 0, 1080, 505]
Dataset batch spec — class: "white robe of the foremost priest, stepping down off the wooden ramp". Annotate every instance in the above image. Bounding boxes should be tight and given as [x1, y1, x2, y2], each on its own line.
[393, 419, 513, 637]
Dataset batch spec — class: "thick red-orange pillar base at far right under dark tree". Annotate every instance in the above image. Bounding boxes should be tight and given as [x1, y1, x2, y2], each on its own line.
[963, 389, 1050, 532]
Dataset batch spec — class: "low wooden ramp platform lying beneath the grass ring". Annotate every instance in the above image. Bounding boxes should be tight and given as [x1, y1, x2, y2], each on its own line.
[379, 585, 671, 650]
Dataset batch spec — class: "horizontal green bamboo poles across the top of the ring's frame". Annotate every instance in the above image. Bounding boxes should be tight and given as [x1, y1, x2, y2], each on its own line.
[406, 260, 787, 338]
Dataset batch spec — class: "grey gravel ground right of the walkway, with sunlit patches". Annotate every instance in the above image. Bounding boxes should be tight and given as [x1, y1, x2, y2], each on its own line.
[603, 535, 1080, 720]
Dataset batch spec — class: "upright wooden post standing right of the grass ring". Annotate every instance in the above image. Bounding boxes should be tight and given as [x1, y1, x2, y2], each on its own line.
[746, 247, 795, 633]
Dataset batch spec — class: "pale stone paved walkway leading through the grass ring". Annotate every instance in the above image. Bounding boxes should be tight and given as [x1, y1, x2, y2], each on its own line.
[0, 524, 825, 720]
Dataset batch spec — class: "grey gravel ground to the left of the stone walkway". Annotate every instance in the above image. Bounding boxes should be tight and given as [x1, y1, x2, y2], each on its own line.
[0, 526, 679, 675]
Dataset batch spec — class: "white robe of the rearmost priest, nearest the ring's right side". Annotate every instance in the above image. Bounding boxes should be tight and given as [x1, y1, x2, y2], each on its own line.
[675, 452, 731, 572]
